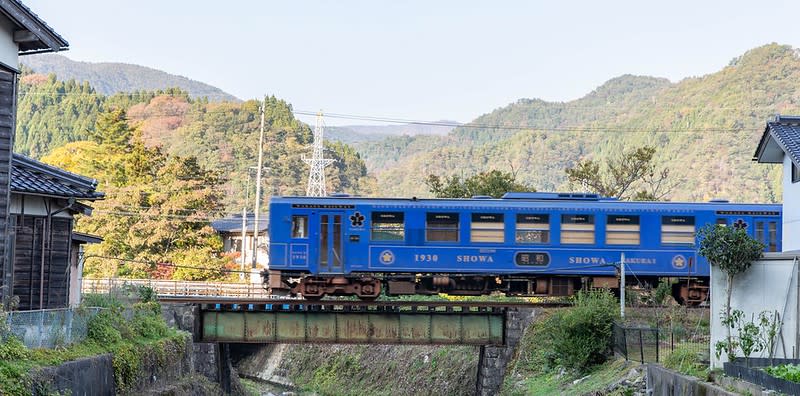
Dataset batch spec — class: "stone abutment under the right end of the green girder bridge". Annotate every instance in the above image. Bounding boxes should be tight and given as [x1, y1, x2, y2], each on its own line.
[475, 308, 535, 396]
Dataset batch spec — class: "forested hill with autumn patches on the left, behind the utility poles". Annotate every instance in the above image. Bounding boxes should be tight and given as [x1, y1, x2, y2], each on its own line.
[15, 74, 374, 213]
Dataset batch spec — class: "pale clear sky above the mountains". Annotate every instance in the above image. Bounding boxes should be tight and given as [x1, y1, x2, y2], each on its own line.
[22, 0, 800, 125]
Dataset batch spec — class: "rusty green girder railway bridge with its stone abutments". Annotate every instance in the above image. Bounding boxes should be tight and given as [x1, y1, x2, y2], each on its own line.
[160, 295, 541, 394]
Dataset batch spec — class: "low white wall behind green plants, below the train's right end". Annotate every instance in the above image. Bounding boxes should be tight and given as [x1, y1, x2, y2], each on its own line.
[709, 253, 800, 367]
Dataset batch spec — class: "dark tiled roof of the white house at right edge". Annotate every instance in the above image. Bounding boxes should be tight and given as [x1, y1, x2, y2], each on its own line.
[753, 115, 800, 166]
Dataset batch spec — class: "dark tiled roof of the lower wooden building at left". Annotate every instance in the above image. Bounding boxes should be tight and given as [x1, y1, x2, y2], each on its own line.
[11, 154, 104, 200]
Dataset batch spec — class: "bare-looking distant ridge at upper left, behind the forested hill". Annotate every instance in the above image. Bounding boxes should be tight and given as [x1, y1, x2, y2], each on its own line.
[22, 54, 240, 102]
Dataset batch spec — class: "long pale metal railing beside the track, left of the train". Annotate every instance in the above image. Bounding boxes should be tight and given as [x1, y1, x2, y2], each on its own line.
[81, 278, 271, 298]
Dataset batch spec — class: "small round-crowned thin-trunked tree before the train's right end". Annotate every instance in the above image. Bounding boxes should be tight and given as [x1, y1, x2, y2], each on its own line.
[698, 224, 764, 360]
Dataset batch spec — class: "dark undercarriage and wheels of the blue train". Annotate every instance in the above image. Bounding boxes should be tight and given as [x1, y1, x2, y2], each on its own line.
[264, 271, 709, 305]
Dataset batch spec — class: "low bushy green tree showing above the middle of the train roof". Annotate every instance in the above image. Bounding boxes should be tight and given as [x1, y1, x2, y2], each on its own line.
[425, 170, 536, 198]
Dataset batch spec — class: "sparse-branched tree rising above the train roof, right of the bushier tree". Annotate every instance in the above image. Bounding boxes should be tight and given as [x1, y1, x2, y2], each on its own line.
[565, 146, 672, 201]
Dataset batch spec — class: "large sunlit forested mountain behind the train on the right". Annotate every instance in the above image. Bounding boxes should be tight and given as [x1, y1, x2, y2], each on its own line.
[355, 44, 800, 202]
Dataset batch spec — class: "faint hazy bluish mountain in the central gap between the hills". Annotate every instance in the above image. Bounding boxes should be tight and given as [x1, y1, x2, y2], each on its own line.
[325, 121, 458, 143]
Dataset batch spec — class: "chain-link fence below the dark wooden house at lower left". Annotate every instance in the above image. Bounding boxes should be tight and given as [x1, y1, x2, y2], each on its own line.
[4, 308, 102, 348]
